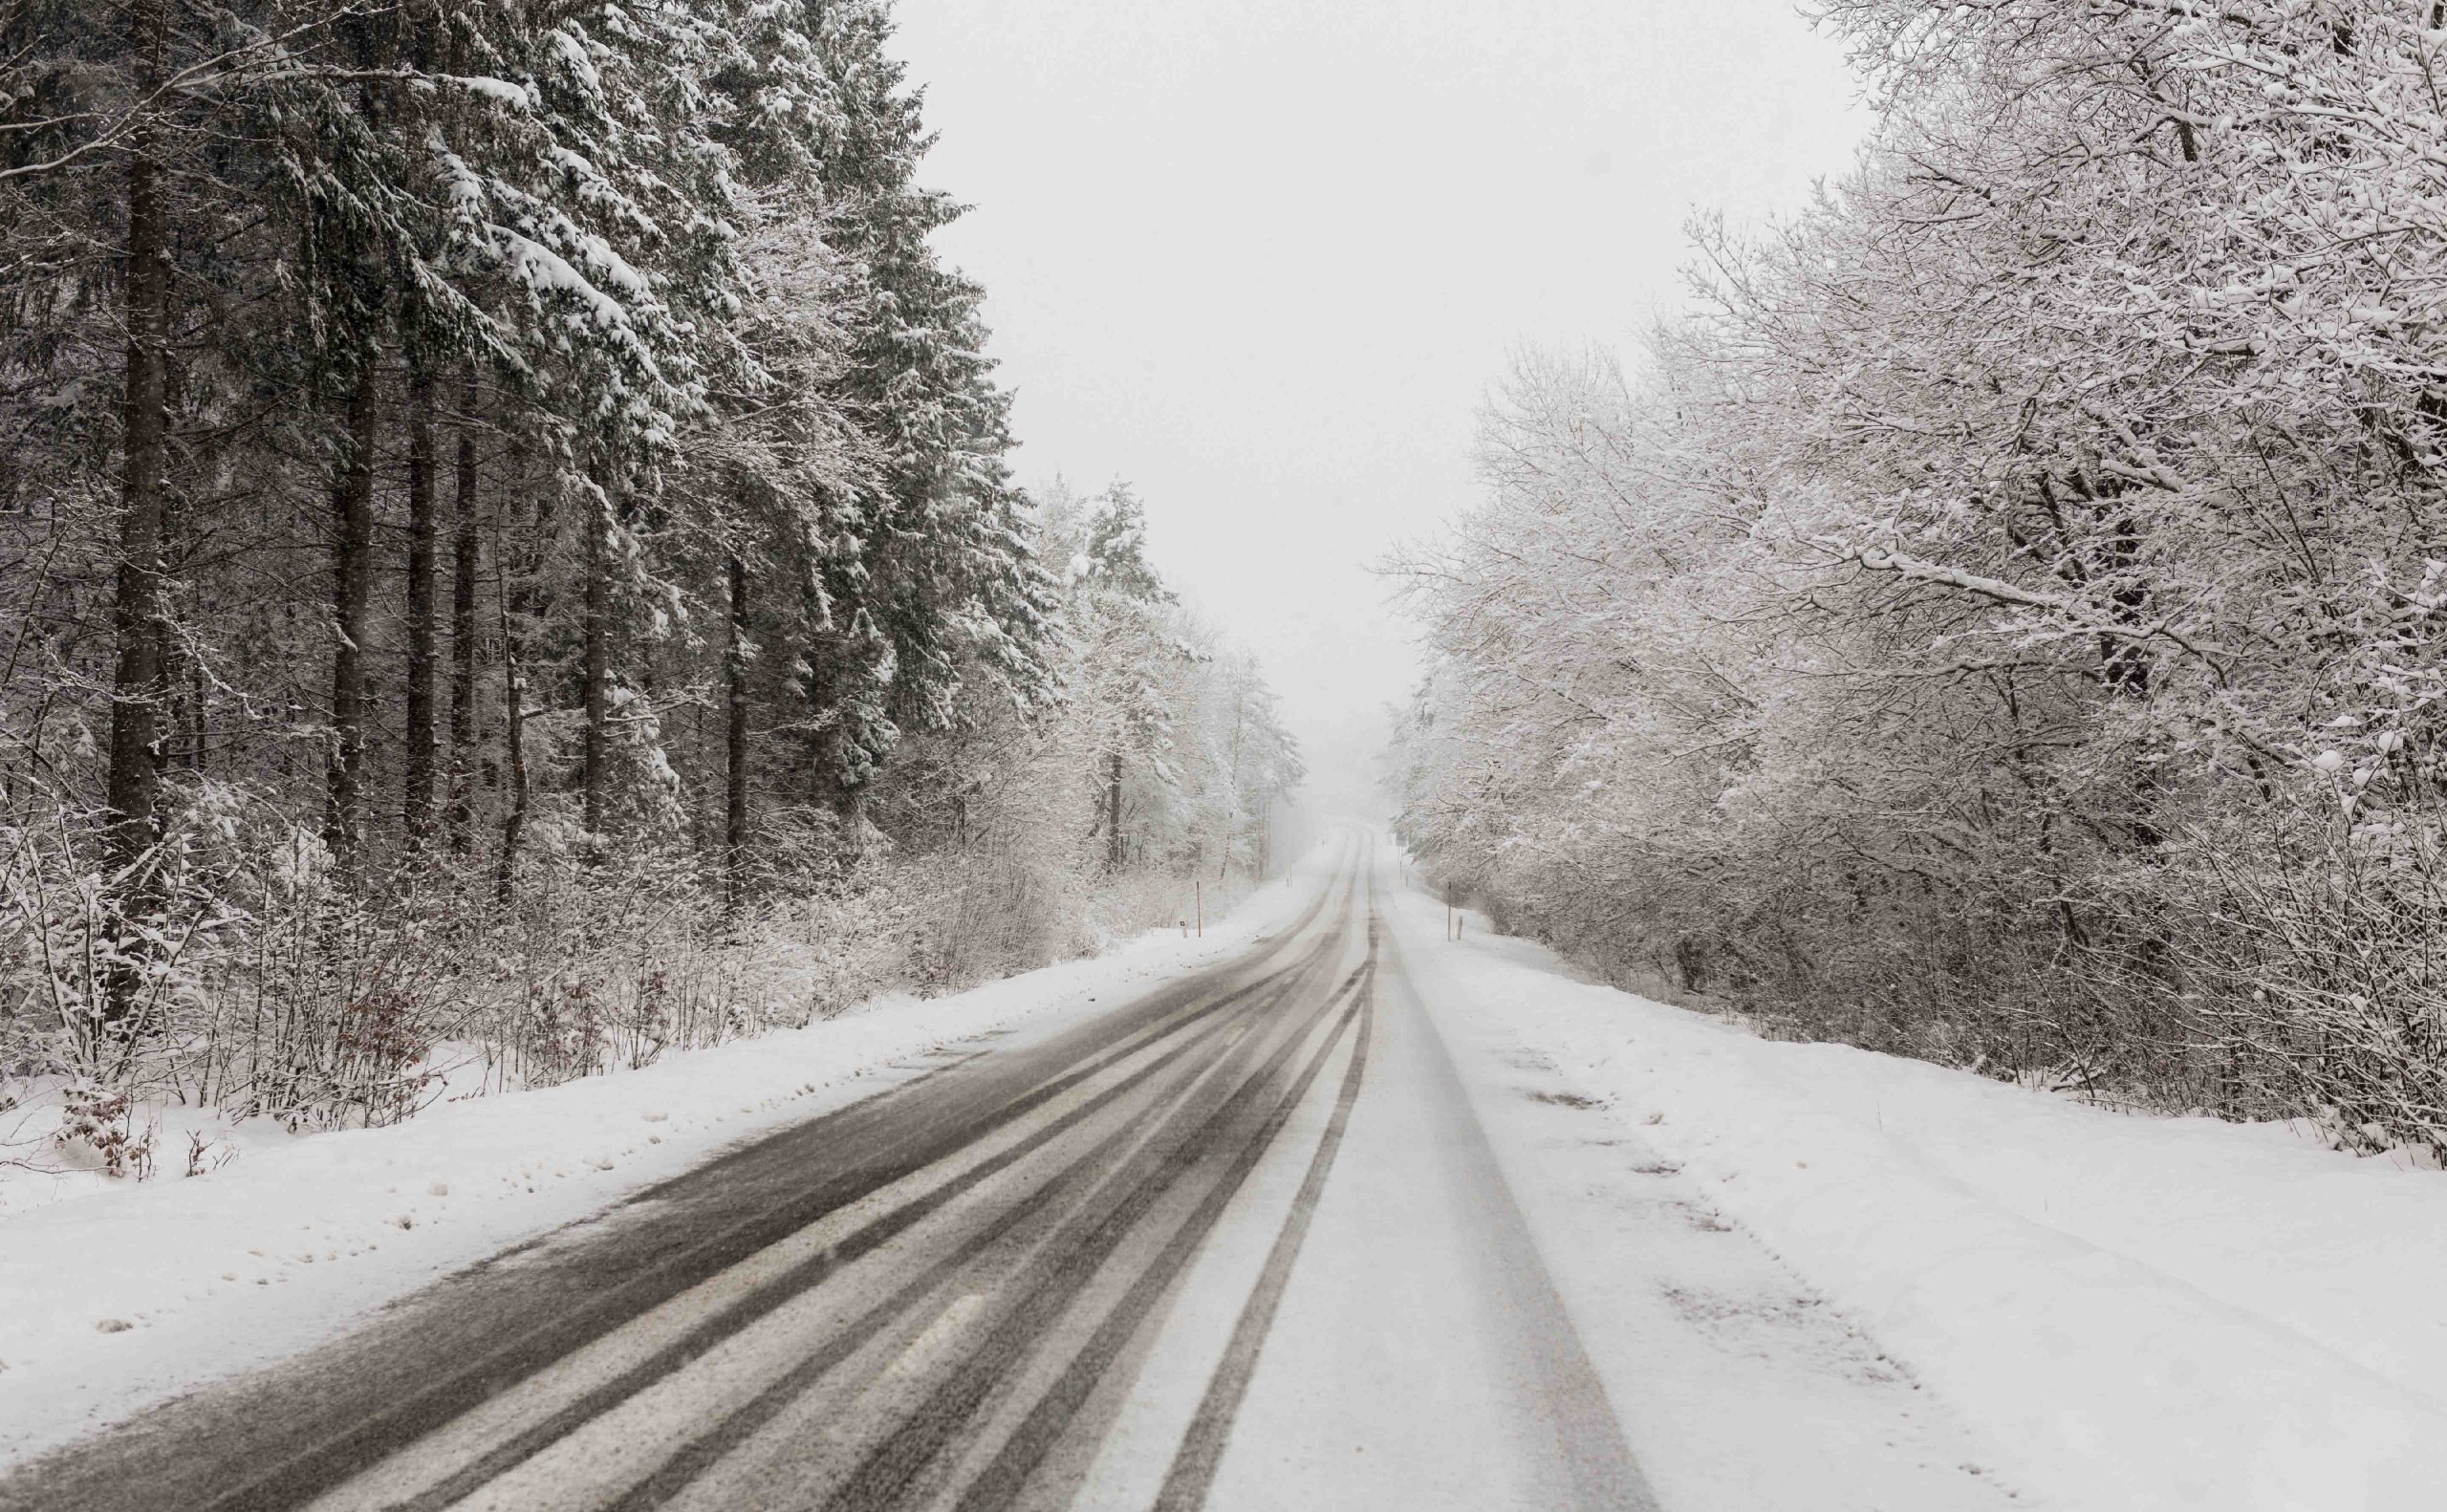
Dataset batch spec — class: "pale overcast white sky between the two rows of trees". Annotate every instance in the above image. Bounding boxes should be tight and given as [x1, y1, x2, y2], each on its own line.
[900, 0, 1865, 808]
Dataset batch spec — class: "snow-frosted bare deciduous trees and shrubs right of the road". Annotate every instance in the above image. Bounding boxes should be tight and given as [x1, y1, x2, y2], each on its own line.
[1397, 0, 2447, 1150]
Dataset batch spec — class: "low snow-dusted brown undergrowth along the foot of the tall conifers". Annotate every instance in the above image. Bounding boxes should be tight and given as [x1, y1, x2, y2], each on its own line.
[0, 853, 1258, 1219]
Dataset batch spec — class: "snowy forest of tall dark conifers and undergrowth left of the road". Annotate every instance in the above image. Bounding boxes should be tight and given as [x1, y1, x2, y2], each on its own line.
[0, 0, 1302, 1159]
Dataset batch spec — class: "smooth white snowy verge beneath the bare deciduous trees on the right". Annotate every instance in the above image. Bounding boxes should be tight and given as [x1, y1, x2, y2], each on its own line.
[1393, 875, 2447, 1512]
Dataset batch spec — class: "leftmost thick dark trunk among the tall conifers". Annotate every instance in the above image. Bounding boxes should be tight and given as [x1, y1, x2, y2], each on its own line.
[103, 0, 169, 1027]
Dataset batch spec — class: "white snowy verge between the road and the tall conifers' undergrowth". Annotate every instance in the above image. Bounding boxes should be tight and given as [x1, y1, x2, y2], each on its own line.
[0, 849, 1333, 1465]
